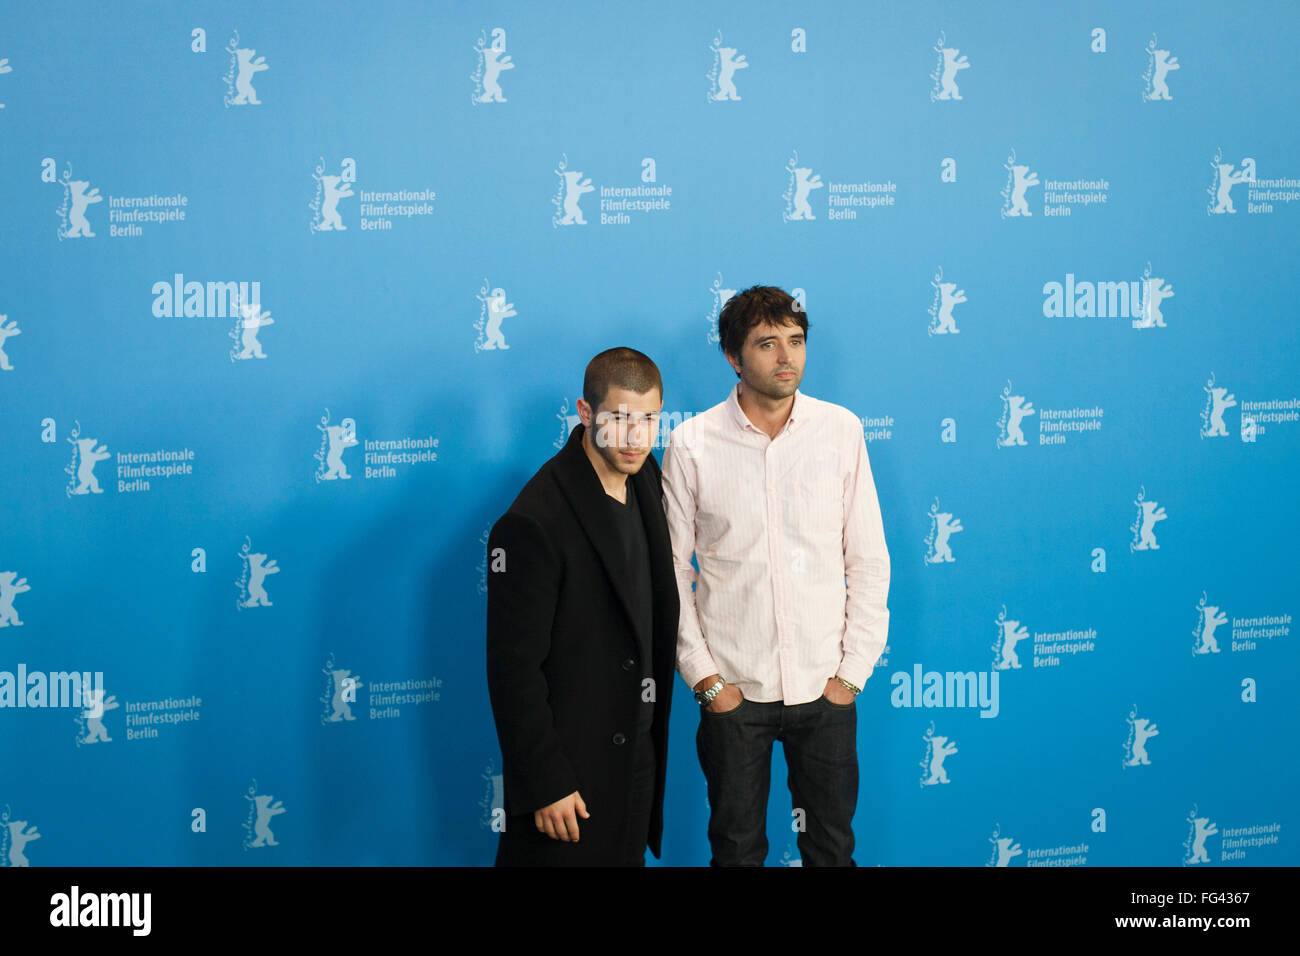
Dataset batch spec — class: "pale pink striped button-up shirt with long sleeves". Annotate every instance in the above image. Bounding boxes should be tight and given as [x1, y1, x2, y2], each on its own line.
[663, 382, 889, 705]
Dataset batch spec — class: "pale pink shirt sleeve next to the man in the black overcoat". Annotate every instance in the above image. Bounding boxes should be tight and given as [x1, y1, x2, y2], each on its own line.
[663, 425, 719, 687]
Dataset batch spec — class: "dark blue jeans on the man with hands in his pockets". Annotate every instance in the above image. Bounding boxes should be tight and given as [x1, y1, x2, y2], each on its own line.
[696, 697, 858, 866]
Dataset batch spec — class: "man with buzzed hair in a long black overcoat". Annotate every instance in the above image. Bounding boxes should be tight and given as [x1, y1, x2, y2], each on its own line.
[488, 349, 677, 866]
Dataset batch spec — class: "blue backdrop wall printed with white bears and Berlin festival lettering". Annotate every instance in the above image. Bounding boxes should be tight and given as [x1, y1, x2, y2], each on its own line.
[0, 0, 1300, 866]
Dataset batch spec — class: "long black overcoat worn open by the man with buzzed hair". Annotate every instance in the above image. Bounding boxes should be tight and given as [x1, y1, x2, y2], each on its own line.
[488, 423, 679, 866]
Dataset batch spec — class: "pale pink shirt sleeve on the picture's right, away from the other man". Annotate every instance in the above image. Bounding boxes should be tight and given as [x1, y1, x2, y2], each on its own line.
[837, 419, 889, 688]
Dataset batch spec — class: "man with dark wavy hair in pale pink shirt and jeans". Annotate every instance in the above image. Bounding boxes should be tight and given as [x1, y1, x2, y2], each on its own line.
[663, 286, 889, 866]
